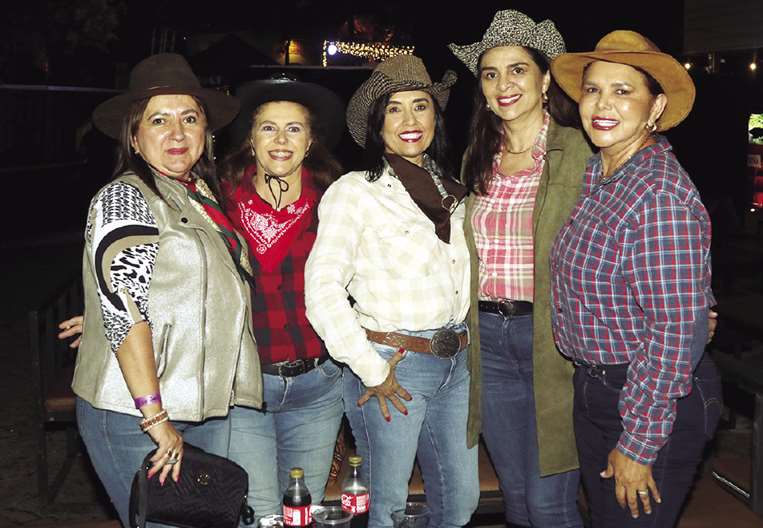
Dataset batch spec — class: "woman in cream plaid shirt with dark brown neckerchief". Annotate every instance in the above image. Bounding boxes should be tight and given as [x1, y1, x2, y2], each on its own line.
[305, 55, 479, 528]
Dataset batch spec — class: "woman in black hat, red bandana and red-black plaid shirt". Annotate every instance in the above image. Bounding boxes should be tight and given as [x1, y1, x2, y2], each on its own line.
[216, 75, 344, 518]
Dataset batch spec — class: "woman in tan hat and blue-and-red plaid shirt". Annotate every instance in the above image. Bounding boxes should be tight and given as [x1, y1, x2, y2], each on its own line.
[551, 30, 720, 528]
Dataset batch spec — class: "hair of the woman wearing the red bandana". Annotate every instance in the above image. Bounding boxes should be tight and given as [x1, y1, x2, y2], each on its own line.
[220, 101, 343, 196]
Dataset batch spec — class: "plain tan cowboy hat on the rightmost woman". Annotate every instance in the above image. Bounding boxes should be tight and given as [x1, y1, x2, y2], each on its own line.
[551, 29, 696, 130]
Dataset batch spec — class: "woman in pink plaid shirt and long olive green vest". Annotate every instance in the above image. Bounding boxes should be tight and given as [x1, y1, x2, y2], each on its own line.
[449, 10, 591, 527]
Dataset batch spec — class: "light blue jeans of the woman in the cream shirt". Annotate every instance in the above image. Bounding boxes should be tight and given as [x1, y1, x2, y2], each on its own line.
[344, 331, 479, 528]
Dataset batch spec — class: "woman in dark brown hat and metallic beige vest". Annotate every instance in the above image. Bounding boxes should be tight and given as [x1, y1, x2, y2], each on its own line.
[66, 54, 262, 526]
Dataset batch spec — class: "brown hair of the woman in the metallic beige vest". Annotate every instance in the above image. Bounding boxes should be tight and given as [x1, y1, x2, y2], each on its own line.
[114, 96, 220, 200]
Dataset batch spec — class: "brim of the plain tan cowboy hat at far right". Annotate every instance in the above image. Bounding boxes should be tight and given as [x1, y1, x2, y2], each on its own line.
[551, 51, 696, 131]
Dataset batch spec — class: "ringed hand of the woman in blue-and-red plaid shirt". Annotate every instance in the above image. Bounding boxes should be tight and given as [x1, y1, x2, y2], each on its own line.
[601, 448, 662, 519]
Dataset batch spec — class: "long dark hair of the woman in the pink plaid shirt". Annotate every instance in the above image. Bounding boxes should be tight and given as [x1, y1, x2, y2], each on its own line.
[464, 47, 580, 194]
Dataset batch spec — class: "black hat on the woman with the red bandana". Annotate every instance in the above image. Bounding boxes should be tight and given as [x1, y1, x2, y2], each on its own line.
[229, 73, 344, 150]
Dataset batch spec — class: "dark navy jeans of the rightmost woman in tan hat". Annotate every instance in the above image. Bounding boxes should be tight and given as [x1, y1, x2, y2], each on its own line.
[573, 355, 722, 528]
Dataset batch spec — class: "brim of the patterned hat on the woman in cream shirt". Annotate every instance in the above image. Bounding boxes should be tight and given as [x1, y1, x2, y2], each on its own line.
[347, 70, 457, 148]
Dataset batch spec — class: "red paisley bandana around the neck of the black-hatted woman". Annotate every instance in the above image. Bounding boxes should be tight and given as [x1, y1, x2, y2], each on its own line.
[228, 165, 318, 271]
